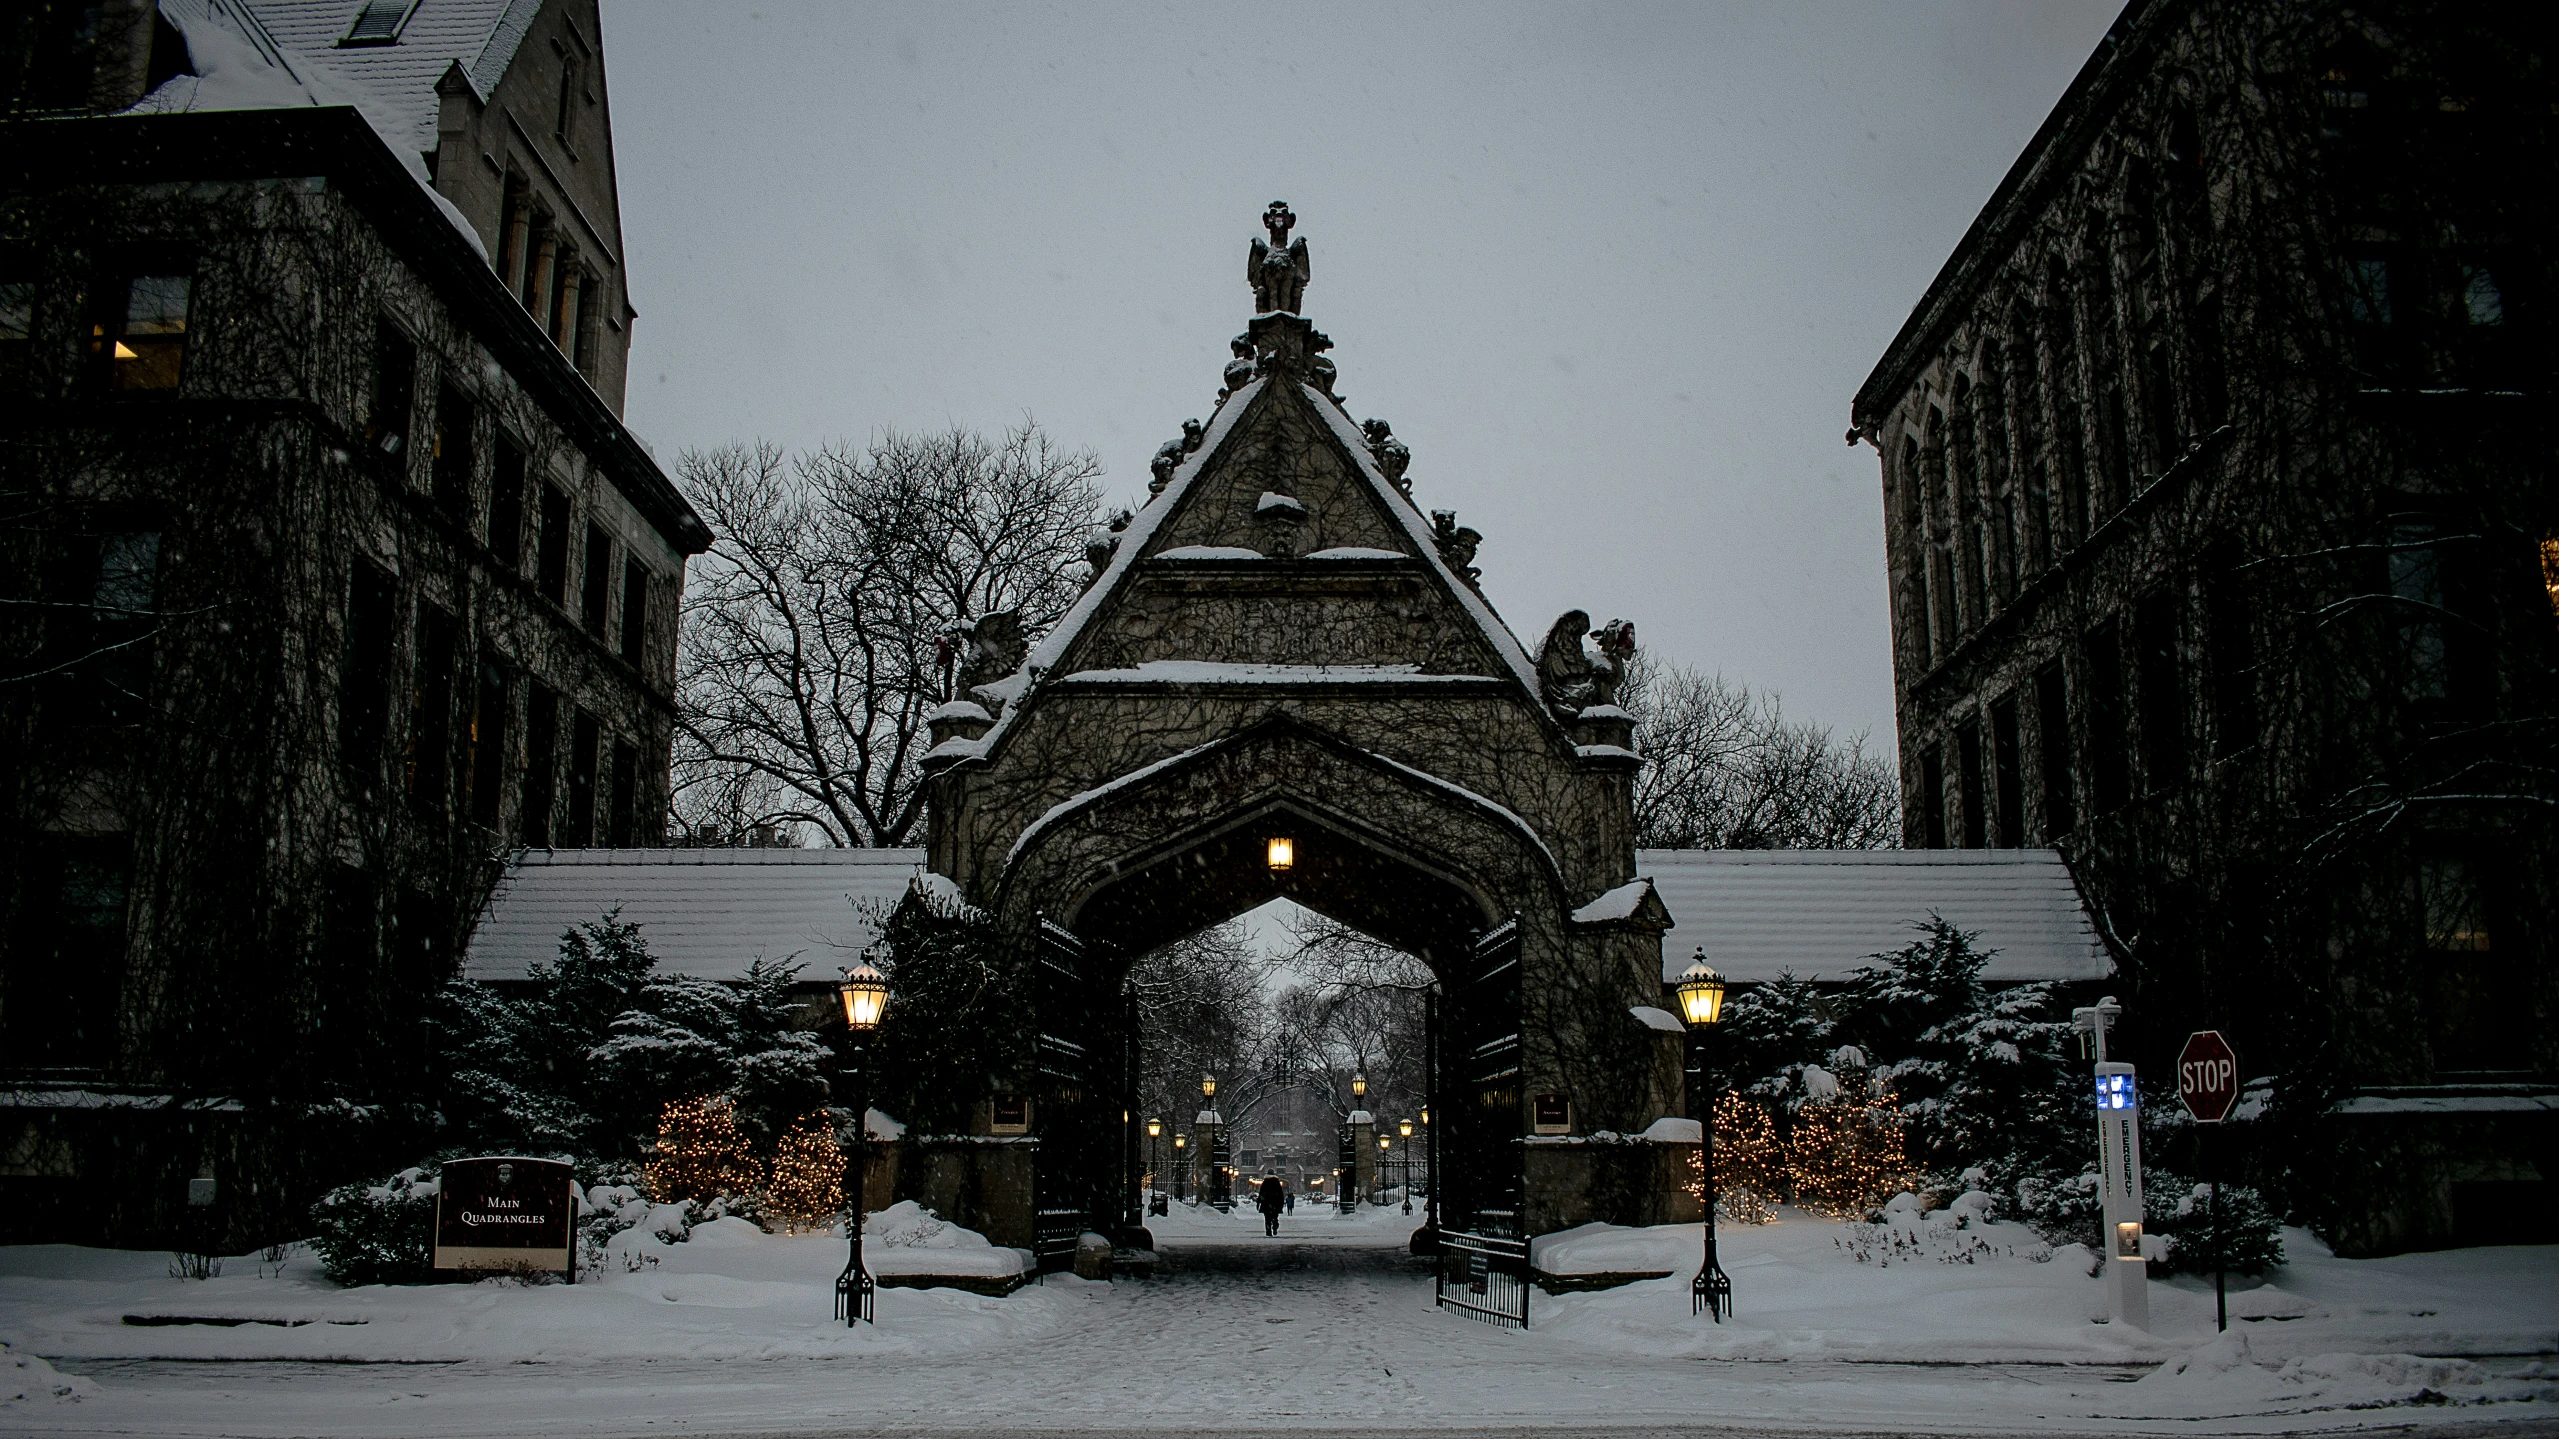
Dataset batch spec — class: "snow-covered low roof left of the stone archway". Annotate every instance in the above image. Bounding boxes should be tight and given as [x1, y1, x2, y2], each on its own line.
[463, 850, 924, 981]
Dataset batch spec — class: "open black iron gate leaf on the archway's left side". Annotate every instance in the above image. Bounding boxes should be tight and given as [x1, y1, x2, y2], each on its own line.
[1031, 917, 1095, 1273]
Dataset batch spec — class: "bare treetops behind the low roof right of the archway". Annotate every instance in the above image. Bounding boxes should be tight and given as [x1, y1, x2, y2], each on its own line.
[1617, 650, 1901, 850]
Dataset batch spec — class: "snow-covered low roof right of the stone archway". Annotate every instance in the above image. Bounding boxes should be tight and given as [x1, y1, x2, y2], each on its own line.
[1635, 850, 2114, 983]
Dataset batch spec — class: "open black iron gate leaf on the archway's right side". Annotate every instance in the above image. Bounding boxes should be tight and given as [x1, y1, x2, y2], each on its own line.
[1430, 914, 1528, 1329]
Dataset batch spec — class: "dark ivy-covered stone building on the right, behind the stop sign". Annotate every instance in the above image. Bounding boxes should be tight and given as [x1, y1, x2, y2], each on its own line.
[1850, 0, 2559, 1252]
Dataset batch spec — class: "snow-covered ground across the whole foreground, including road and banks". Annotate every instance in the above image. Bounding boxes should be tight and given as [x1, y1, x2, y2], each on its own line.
[0, 1203, 2559, 1434]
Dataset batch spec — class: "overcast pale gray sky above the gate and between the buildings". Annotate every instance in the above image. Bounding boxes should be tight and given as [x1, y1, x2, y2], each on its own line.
[604, 0, 2119, 745]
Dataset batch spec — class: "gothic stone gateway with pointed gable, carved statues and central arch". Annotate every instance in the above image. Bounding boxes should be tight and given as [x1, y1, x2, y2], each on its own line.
[924, 205, 1679, 1293]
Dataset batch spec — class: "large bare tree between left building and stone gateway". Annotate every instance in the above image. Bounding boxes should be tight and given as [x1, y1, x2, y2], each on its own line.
[673, 420, 1100, 845]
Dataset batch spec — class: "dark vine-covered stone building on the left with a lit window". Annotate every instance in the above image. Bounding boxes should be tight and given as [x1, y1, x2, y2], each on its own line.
[0, 0, 706, 1244]
